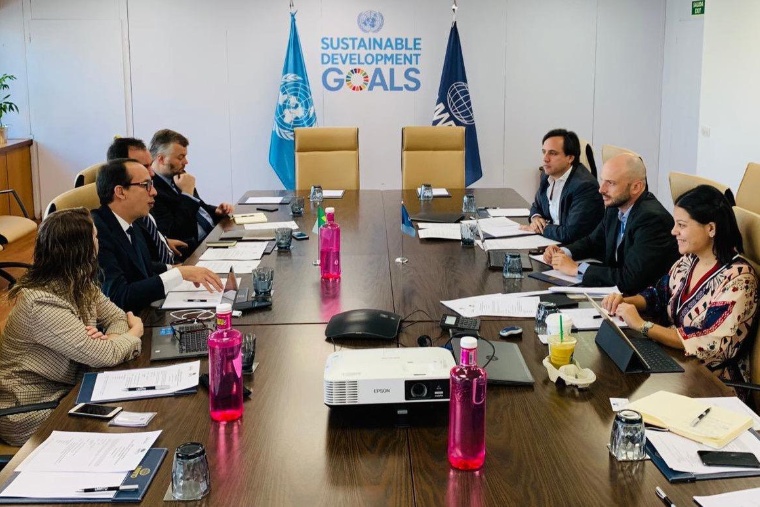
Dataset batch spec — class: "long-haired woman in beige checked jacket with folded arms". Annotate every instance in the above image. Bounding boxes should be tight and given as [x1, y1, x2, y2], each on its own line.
[0, 208, 143, 445]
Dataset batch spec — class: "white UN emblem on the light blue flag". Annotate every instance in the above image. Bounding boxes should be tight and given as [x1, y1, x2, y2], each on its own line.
[273, 74, 317, 141]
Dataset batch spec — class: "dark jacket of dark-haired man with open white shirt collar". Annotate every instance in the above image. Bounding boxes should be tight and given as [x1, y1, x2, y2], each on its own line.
[530, 164, 604, 243]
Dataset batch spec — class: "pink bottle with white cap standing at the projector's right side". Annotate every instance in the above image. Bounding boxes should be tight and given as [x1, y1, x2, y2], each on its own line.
[448, 336, 487, 470]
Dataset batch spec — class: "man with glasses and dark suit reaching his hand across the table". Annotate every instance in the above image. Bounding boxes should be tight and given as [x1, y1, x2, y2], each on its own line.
[92, 159, 222, 312]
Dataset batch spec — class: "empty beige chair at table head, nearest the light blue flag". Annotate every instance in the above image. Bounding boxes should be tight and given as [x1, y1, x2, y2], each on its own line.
[293, 127, 359, 190]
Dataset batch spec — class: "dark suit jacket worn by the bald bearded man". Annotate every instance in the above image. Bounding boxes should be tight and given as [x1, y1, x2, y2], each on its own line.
[567, 192, 679, 295]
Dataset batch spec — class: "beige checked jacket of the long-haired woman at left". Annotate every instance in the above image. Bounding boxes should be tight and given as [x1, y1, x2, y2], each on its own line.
[0, 289, 142, 445]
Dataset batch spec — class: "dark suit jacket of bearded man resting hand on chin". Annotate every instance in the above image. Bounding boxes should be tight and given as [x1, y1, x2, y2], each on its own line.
[151, 175, 221, 258]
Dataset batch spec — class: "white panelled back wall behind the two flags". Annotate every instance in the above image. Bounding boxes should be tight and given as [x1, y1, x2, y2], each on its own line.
[0, 0, 665, 214]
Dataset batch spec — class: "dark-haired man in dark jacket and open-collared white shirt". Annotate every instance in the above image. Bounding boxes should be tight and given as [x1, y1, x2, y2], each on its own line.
[520, 129, 604, 243]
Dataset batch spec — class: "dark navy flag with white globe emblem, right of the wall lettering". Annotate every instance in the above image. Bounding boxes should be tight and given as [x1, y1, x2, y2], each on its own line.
[433, 21, 483, 186]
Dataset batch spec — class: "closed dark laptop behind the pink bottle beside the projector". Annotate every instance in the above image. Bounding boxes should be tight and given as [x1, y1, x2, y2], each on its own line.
[452, 338, 534, 386]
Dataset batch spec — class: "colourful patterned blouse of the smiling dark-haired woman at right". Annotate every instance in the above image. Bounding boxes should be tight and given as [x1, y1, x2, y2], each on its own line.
[641, 254, 758, 382]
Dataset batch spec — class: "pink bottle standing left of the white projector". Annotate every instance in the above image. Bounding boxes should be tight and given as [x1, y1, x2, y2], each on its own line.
[208, 305, 243, 422]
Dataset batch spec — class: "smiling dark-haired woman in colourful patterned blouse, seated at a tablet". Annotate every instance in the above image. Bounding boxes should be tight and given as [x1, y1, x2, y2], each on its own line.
[602, 185, 757, 382]
